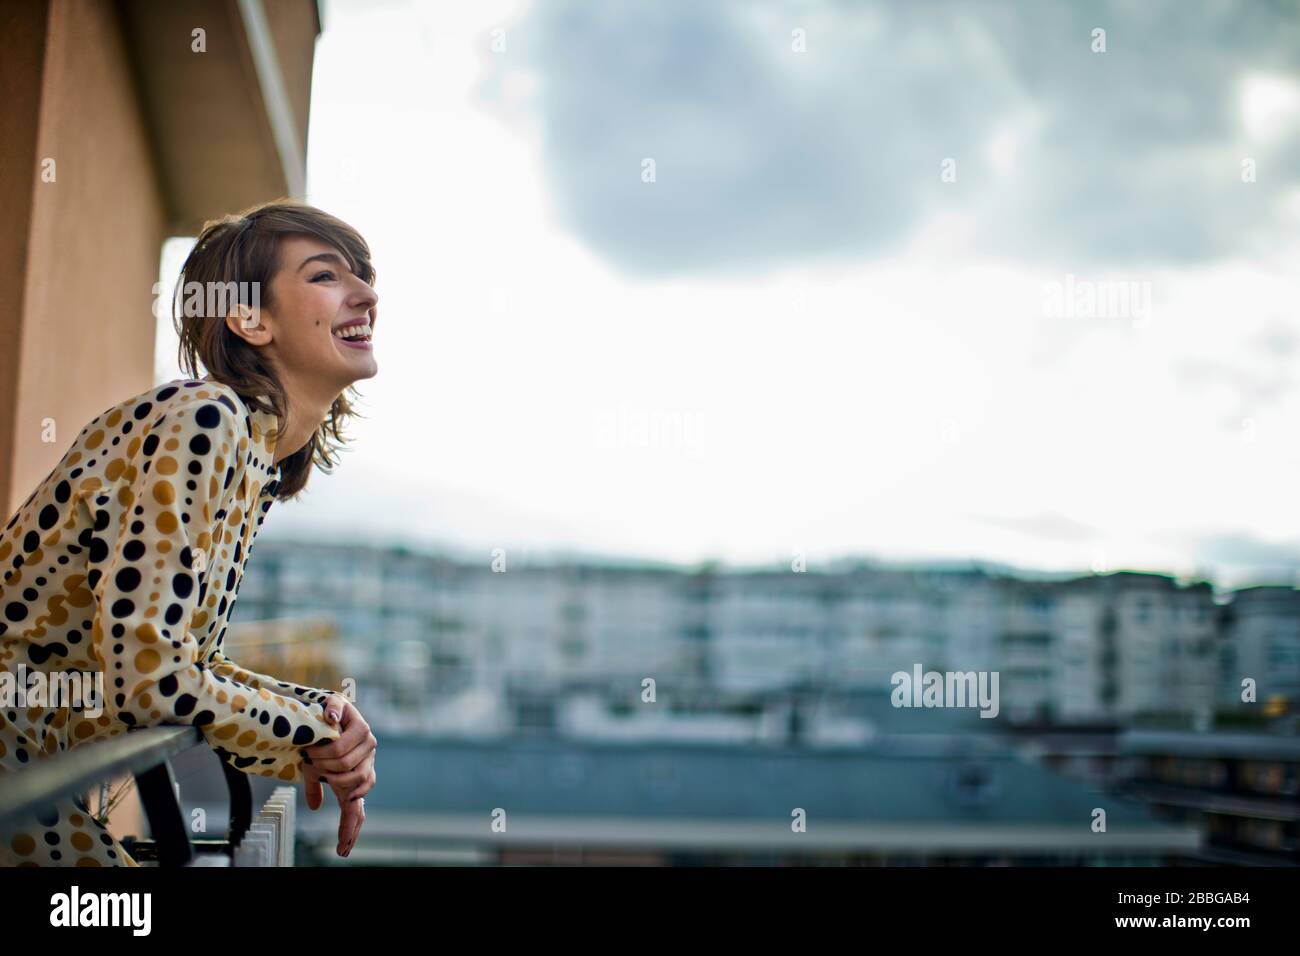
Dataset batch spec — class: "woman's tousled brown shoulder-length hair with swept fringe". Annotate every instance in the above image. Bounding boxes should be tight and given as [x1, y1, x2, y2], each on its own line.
[173, 199, 374, 501]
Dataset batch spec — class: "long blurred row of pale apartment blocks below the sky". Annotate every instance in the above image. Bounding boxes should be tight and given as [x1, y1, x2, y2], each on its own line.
[237, 537, 1268, 726]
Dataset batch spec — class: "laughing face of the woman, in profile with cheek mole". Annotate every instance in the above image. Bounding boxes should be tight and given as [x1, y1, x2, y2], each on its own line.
[261, 235, 380, 394]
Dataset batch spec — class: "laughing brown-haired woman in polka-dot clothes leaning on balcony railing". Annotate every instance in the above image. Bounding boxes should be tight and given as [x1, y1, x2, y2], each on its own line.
[0, 202, 378, 866]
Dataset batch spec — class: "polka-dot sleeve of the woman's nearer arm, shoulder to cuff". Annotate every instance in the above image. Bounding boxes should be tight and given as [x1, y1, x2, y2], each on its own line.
[87, 397, 339, 783]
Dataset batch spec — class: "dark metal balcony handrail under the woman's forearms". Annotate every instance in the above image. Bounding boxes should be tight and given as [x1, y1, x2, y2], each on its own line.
[0, 726, 252, 866]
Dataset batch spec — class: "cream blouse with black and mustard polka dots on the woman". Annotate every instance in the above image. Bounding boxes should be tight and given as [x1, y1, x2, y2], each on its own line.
[0, 380, 338, 832]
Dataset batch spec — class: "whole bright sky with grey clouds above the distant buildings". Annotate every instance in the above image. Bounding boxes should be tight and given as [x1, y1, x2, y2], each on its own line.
[160, 0, 1300, 584]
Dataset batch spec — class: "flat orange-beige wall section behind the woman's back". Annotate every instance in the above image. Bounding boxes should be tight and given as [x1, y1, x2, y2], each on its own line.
[5, 3, 166, 515]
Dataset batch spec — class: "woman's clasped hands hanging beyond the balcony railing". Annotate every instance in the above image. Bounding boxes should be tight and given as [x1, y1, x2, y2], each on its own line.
[303, 693, 378, 856]
